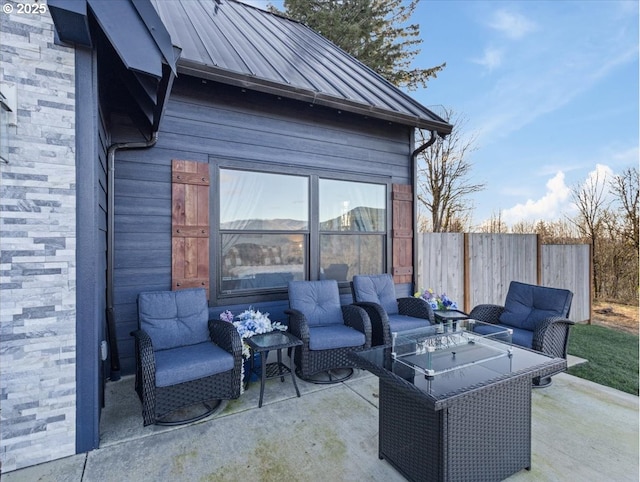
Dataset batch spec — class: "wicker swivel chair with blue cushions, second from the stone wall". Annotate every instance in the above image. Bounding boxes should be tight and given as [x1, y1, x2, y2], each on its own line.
[285, 280, 371, 383]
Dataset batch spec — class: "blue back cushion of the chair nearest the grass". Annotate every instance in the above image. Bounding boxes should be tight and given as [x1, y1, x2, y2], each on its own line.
[500, 281, 573, 331]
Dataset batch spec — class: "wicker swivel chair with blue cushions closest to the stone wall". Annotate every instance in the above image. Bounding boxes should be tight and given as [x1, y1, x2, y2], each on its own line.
[131, 288, 242, 426]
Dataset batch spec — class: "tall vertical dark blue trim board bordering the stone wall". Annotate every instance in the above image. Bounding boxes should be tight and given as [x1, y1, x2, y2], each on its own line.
[75, 47, 106, 453]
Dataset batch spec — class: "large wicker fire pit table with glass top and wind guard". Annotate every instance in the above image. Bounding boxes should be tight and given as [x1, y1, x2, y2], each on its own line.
[349, 320, 566, 480]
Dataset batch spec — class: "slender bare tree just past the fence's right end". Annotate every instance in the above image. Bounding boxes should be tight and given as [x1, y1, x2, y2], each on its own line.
[571, 170, 606, 298]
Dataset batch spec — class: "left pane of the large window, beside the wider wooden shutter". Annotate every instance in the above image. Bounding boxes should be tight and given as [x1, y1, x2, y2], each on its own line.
[219, 169, 309, 294]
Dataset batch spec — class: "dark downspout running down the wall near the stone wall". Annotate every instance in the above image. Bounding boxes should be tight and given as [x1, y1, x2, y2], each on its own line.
[107, 131, 158, 381]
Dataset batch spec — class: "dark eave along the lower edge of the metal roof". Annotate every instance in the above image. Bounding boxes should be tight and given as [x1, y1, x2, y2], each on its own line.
[178, 59, 452, 136]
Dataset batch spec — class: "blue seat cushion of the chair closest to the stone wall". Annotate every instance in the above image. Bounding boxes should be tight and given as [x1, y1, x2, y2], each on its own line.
[155, 341, 234, 387]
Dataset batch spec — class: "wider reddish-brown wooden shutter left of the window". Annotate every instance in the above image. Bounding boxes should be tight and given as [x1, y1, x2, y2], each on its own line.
[171, 159, 209, 299]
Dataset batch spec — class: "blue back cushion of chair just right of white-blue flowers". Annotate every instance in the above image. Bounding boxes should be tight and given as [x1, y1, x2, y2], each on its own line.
[289, 280, 344, 326]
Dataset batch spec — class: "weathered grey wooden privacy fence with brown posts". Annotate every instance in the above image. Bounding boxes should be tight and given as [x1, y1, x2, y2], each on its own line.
[416, 233, 591, 322]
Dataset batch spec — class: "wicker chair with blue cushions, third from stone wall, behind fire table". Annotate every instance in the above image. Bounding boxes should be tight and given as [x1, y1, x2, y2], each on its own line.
[351, 274, 435, 346]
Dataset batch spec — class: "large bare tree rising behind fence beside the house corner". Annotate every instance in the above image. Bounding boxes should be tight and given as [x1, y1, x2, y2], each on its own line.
[417, 108, 485, 233]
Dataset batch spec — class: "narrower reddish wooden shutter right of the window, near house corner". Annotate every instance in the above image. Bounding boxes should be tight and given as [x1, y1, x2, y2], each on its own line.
[391, 184, 413, 283]
